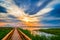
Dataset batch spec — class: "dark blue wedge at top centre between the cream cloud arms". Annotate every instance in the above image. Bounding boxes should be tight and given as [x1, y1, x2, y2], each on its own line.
[13, 0, 52, 15]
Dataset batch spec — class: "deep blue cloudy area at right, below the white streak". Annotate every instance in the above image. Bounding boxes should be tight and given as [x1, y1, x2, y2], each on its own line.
[40, 4, 60, 26]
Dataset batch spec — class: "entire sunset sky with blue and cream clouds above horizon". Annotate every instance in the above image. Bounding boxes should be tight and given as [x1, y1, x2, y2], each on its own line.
[0, 0, 60, 26]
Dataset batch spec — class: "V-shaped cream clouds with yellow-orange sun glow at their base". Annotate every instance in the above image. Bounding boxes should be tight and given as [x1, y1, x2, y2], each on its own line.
[1, 0, 53, 26]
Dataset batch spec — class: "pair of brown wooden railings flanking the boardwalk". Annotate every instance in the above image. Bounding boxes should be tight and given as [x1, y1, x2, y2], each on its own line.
[2, 29, 31, 40]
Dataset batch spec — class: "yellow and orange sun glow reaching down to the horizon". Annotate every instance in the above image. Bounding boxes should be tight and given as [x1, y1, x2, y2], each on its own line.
[19, 16, 38, 26]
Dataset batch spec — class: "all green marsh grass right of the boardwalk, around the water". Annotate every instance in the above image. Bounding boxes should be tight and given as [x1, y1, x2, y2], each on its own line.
[19, 28, 60, 40]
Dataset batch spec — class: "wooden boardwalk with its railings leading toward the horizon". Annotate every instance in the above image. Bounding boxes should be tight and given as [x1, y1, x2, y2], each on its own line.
[2, 28, 31, 40]
